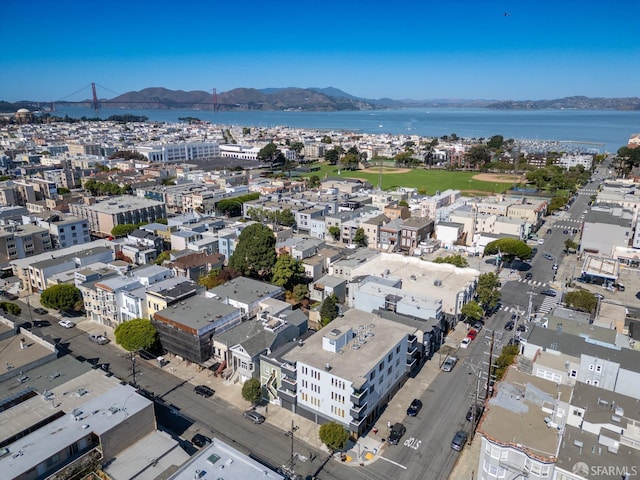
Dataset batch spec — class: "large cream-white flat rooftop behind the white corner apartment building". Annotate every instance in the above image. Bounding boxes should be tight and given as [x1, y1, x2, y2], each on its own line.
[351, 253, 480, 314]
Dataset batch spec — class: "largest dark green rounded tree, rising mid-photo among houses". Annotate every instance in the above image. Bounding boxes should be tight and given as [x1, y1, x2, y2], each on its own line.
[229, 223, 276, 279]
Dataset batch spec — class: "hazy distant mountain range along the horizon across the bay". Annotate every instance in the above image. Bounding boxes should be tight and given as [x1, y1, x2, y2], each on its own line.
[0, 87, 640, 111]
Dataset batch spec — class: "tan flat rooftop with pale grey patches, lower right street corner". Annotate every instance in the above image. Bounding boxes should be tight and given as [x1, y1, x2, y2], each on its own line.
[478, 368, 571, 459]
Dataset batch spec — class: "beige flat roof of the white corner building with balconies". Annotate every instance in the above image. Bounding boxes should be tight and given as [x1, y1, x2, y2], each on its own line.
[283, 308, 417, 385]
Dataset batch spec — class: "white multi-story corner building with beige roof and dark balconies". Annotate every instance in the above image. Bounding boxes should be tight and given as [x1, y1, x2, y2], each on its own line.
[278, 309, 418, 437]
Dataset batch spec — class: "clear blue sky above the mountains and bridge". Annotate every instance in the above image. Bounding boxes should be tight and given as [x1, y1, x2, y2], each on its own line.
[0, 0, 640, 101]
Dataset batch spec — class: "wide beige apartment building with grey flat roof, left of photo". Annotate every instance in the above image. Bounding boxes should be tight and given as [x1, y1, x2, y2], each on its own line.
[69, 195, 167, 237]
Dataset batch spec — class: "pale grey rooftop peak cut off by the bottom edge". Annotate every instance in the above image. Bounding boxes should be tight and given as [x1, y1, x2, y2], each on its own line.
[168, 438, 284, 480]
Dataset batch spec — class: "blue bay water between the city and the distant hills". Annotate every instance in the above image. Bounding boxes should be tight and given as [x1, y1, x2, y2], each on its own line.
[54, 106, 640, 153]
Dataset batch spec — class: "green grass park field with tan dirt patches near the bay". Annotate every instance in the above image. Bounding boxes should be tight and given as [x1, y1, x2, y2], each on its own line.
[305, 163, 514, 195]
